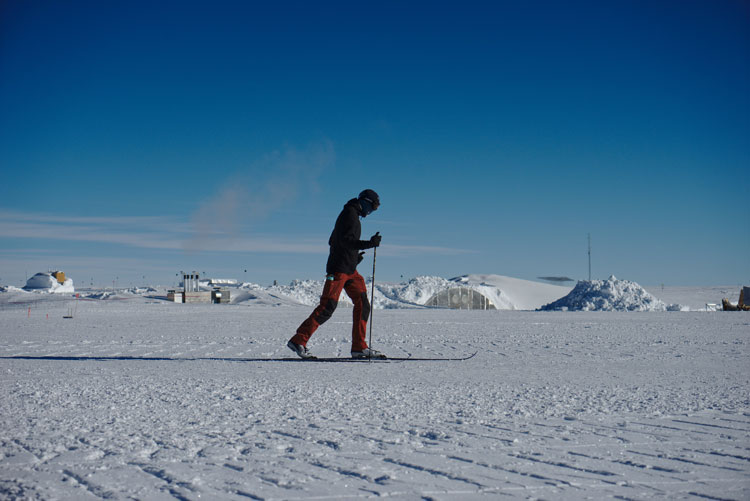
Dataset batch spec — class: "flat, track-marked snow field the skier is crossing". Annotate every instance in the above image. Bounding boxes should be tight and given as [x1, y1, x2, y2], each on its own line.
[0, 299, 750, 499]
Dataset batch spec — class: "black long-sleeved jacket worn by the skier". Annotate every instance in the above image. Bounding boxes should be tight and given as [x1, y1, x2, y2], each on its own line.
[326, 198, 373, 275]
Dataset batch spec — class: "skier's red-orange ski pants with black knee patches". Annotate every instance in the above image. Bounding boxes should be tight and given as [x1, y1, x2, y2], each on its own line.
[291, 270, 370, 351]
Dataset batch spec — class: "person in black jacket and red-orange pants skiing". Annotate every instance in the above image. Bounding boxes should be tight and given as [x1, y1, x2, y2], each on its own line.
[287, 189, 386, 358]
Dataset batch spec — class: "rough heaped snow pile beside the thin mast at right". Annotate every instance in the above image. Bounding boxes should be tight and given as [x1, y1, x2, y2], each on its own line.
[540, 275, 680, 311]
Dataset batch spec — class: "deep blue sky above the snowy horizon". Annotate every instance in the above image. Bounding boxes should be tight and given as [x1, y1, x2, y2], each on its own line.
[0, 0, 750, 285]
